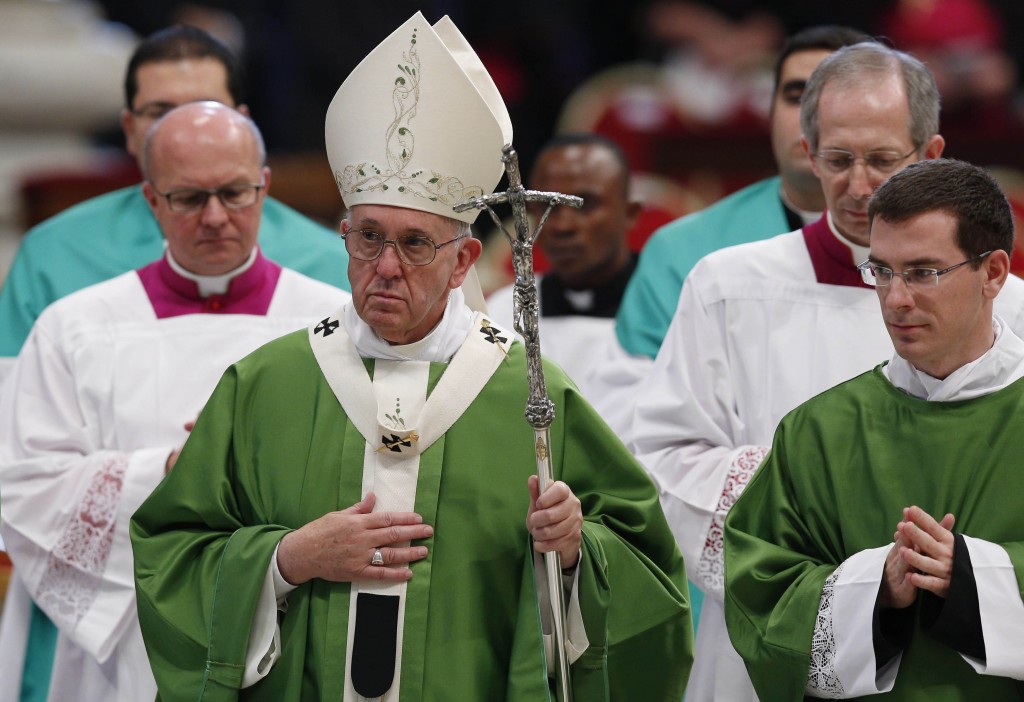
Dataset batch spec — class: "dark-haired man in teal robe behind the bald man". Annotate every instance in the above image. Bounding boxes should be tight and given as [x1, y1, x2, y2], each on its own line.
[0, 26, 348, 380]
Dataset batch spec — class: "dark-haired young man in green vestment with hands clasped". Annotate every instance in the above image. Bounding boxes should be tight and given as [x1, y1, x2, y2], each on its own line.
[725, 159, 1024, 702]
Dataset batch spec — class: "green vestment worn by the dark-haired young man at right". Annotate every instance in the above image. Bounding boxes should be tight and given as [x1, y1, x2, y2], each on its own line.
[725, 366, 1024, 702]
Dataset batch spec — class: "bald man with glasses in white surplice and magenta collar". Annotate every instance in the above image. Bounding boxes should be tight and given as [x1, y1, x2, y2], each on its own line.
[0, 101, 349, 702]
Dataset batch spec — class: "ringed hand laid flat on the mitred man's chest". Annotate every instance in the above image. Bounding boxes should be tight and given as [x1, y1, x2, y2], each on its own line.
[278, 492, 434, 585]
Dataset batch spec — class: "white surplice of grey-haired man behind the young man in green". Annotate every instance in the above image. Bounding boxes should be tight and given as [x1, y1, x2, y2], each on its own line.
[629, 230, 1024, 702]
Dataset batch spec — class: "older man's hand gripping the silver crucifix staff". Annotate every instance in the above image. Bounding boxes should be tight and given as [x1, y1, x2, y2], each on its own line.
[526, 475, 583, 568]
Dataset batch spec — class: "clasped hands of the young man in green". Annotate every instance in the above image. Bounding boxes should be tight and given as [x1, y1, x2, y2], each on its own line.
[879, 507, 955, 609]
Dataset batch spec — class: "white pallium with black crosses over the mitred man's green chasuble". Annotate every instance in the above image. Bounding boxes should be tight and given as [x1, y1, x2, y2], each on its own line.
[309, 302, 513, 702]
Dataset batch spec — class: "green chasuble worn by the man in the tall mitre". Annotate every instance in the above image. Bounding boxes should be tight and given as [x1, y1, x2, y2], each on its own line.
[131, 330, 692, 702]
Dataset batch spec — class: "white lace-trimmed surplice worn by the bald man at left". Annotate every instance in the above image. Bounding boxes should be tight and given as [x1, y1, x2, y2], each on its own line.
[0, 269, 349, 702]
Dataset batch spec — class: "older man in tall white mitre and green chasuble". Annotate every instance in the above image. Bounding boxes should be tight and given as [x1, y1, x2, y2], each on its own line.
[125, 13, 692, 702]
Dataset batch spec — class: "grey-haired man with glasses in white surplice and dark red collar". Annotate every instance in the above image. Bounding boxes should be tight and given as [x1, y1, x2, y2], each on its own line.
[634, 43, 1024, 702]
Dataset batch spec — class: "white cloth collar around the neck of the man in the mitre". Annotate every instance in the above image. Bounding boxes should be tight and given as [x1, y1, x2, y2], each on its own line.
[343, 288, 474, 363]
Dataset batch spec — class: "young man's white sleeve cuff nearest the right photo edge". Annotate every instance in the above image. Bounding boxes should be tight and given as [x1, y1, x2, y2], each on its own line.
[963, 534, 1024, 681]
